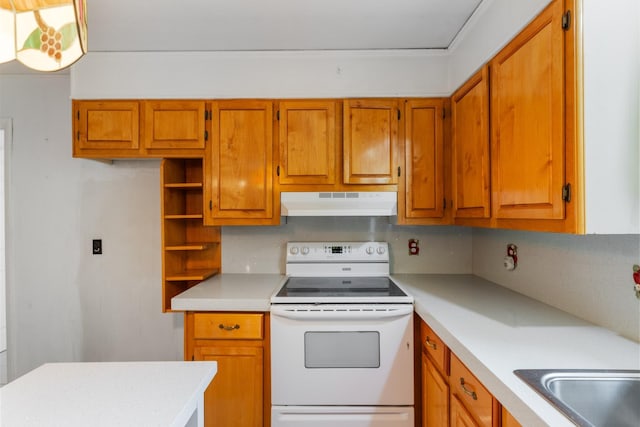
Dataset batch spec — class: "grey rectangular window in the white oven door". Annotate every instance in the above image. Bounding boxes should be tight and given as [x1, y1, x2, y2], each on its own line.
[304, 331, 380, 368]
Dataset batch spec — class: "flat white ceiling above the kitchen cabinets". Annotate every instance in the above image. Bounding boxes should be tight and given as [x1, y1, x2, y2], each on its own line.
[87, 0, 482, 52]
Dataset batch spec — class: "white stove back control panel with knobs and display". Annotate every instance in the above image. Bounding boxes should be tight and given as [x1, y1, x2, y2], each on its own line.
[287, 242, 389, 263]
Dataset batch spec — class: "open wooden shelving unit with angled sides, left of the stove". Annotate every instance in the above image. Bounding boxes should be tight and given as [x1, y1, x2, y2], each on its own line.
[160, 159, 221, 312]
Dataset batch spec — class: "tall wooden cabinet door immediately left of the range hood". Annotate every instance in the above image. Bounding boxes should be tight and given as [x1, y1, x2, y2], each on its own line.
[205, 100, 279, 225]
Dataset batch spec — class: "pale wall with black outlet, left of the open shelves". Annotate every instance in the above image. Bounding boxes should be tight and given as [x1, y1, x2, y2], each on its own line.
[0, 74, 183, 379]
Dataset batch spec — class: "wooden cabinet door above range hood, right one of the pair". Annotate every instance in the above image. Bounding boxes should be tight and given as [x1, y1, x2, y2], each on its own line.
[343, 99, 400, 184]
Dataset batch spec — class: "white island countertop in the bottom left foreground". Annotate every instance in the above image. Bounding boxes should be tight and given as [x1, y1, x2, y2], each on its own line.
[0, 362, 217, 427]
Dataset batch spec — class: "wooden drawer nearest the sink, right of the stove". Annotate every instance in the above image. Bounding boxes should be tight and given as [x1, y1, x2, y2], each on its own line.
[449, 353, 493, 427]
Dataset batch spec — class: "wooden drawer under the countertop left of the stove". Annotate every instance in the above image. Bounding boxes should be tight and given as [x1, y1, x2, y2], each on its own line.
[193, 313, 264, 340]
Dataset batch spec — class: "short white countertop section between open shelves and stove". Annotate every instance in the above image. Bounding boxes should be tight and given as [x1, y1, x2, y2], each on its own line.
[171, 274, 286, 312]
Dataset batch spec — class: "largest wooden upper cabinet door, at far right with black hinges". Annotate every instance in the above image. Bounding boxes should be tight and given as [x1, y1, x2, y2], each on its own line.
[490, 0, 565, 219]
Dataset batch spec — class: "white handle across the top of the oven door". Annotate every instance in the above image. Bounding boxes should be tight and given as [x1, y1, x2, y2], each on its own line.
[271, 304, 413, 320]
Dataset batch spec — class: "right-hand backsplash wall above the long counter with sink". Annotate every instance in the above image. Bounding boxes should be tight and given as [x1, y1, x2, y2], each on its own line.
[473, 229, 640, 342]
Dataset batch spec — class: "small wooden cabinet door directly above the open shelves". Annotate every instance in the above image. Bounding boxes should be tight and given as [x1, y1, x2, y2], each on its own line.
[143, 100, 205, 150]
